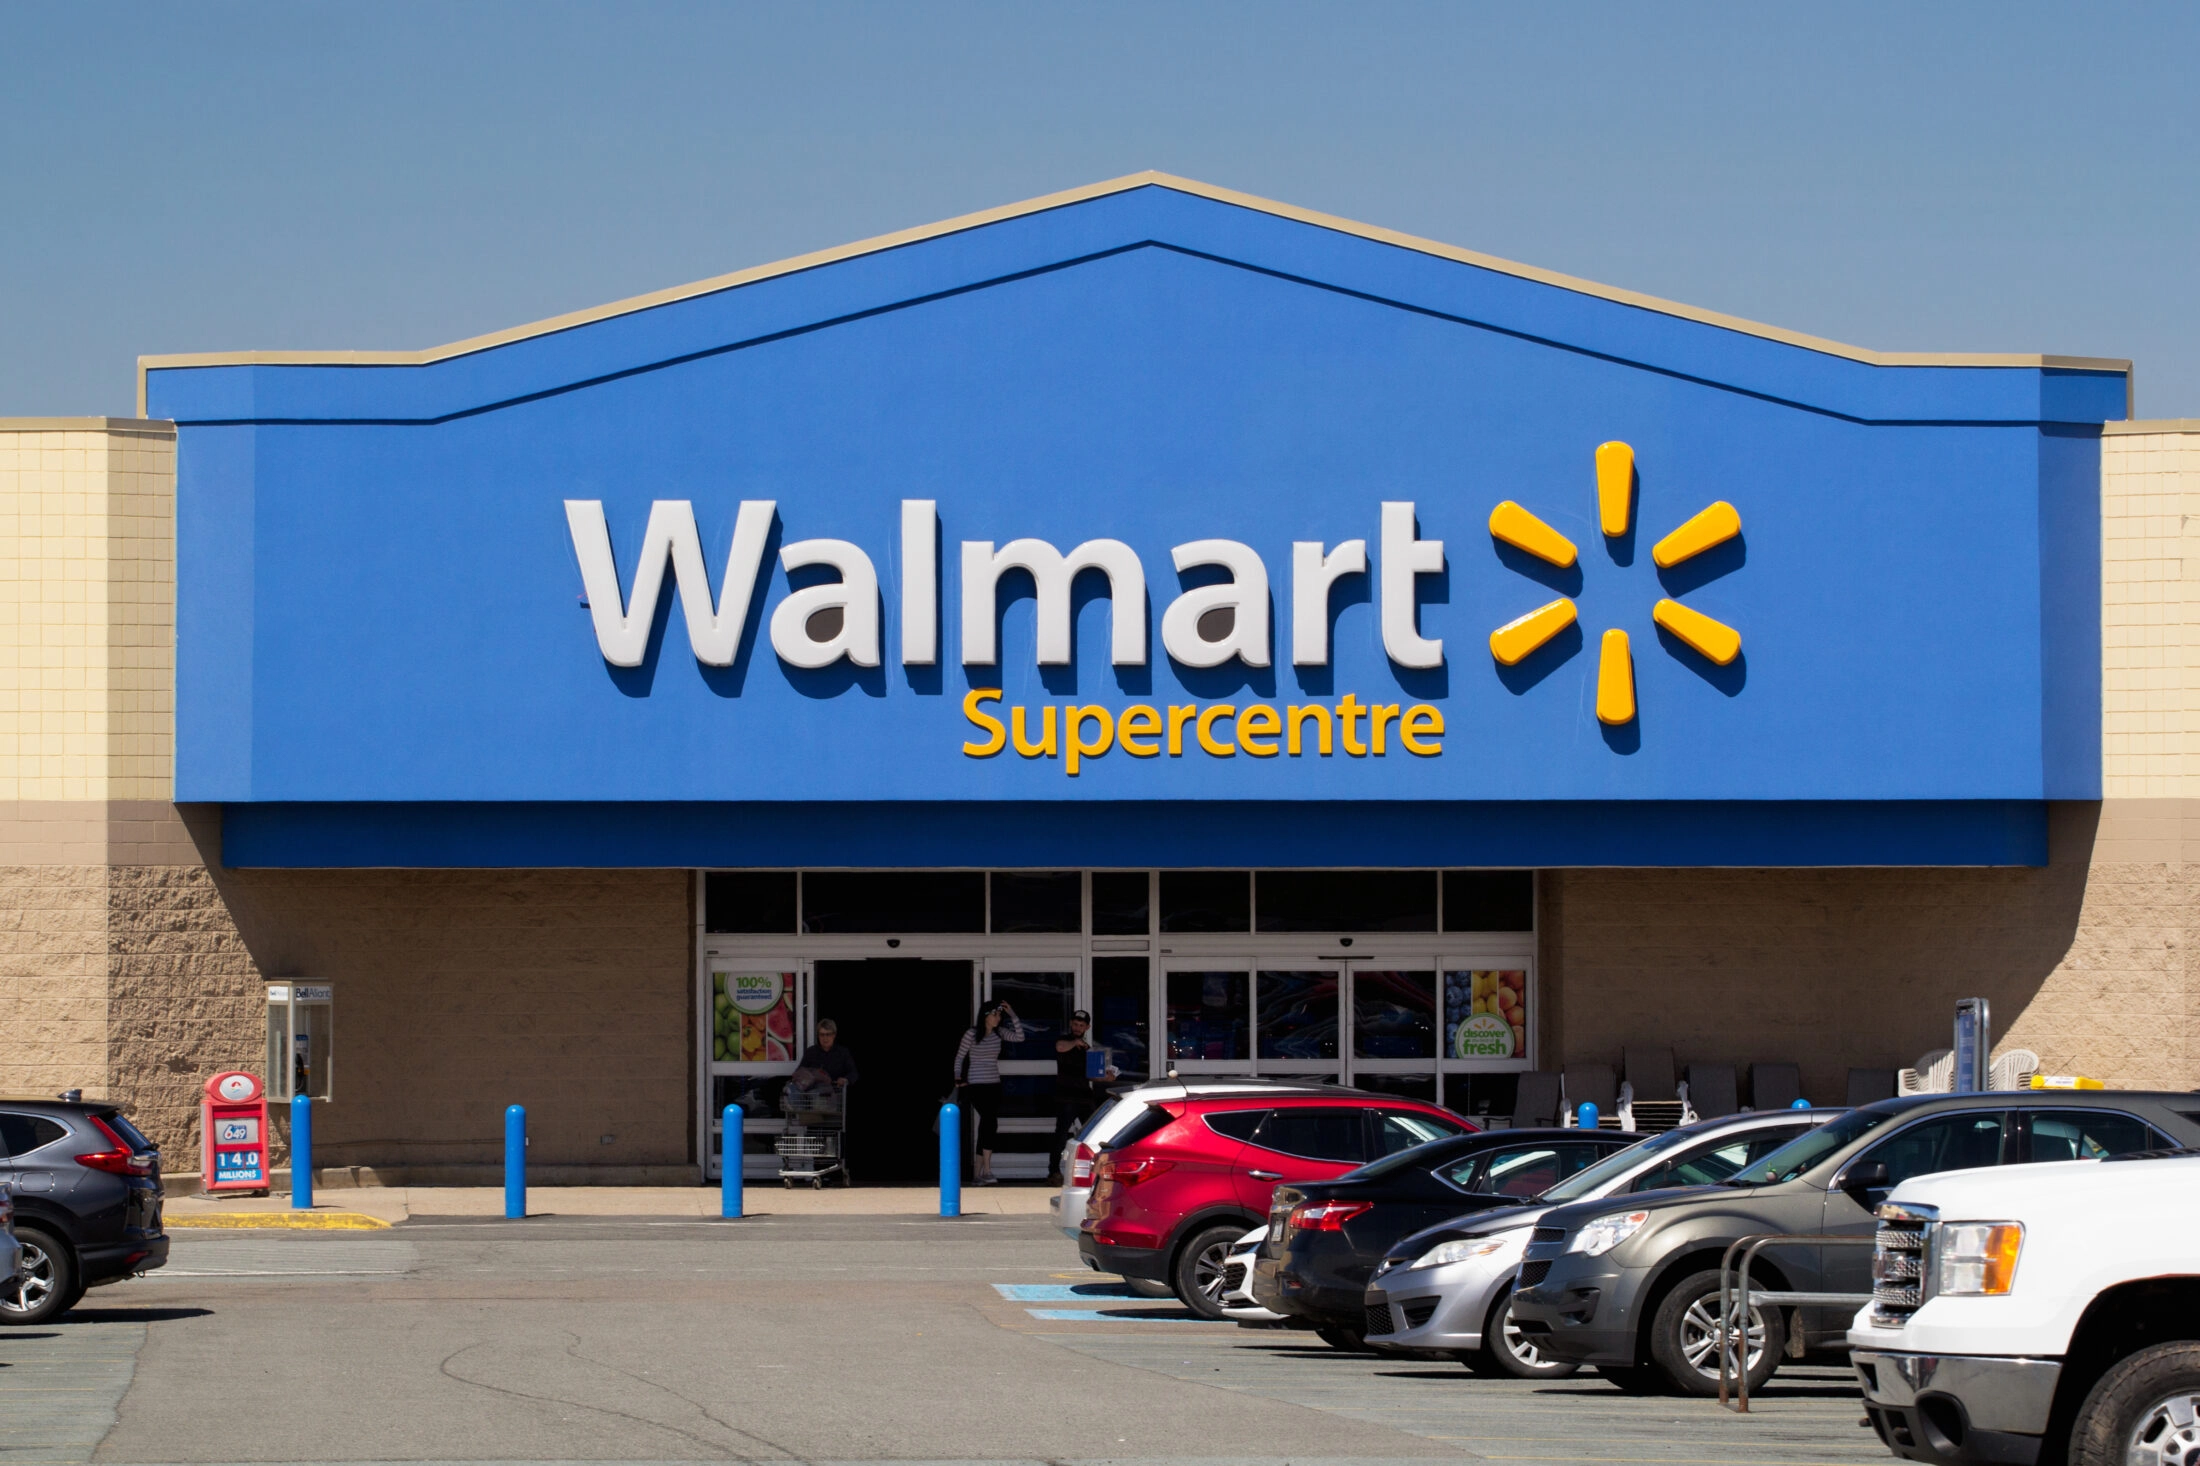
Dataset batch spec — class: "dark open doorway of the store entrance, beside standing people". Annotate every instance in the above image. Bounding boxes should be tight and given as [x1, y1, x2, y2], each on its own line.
[810, 958, 975, 1186]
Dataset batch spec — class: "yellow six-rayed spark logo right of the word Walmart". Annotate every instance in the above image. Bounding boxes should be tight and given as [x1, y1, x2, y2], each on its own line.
[1489, 442, 1742, 726]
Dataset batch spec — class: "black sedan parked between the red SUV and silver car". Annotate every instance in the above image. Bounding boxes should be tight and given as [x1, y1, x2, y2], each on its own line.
[1252, 1129, 1641, 1347]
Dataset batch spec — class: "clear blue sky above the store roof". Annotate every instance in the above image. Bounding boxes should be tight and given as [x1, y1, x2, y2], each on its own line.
[0, 0, 2200, 418]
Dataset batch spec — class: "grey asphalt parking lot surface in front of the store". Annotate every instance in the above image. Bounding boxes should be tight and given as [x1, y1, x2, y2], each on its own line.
[0, 1215, 1890, 1466]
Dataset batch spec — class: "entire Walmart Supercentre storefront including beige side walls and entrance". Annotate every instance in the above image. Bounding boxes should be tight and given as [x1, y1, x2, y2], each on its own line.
[0, 176, 2200, 1180]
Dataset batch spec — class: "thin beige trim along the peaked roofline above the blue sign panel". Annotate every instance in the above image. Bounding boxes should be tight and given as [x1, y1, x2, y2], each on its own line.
[139, 169, 2132, 416]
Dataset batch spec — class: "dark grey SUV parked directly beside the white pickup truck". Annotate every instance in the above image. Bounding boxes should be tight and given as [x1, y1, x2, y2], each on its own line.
[1514, 1090, 2200, 1396]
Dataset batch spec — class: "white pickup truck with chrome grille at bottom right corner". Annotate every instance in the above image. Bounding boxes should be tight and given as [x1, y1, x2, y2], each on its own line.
[1848, 1151, 2200, 1466]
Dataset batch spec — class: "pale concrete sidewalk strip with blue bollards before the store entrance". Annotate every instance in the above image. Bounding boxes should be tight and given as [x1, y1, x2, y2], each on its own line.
[163, 1182, 1056, 1228]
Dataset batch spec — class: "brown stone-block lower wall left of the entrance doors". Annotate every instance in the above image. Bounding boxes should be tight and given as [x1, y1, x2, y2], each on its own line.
[108, 865, 695, 1167]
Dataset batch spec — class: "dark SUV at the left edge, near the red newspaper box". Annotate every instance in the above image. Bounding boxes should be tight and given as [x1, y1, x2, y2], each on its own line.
[0, 1098, 167, 1323]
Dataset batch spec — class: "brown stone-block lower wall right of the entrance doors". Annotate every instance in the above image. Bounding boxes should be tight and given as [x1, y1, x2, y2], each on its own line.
[1542, 801, 2200, 1103]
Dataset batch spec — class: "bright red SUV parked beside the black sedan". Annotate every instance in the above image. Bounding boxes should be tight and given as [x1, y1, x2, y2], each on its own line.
[1078, 1081, 1474, 1319]
